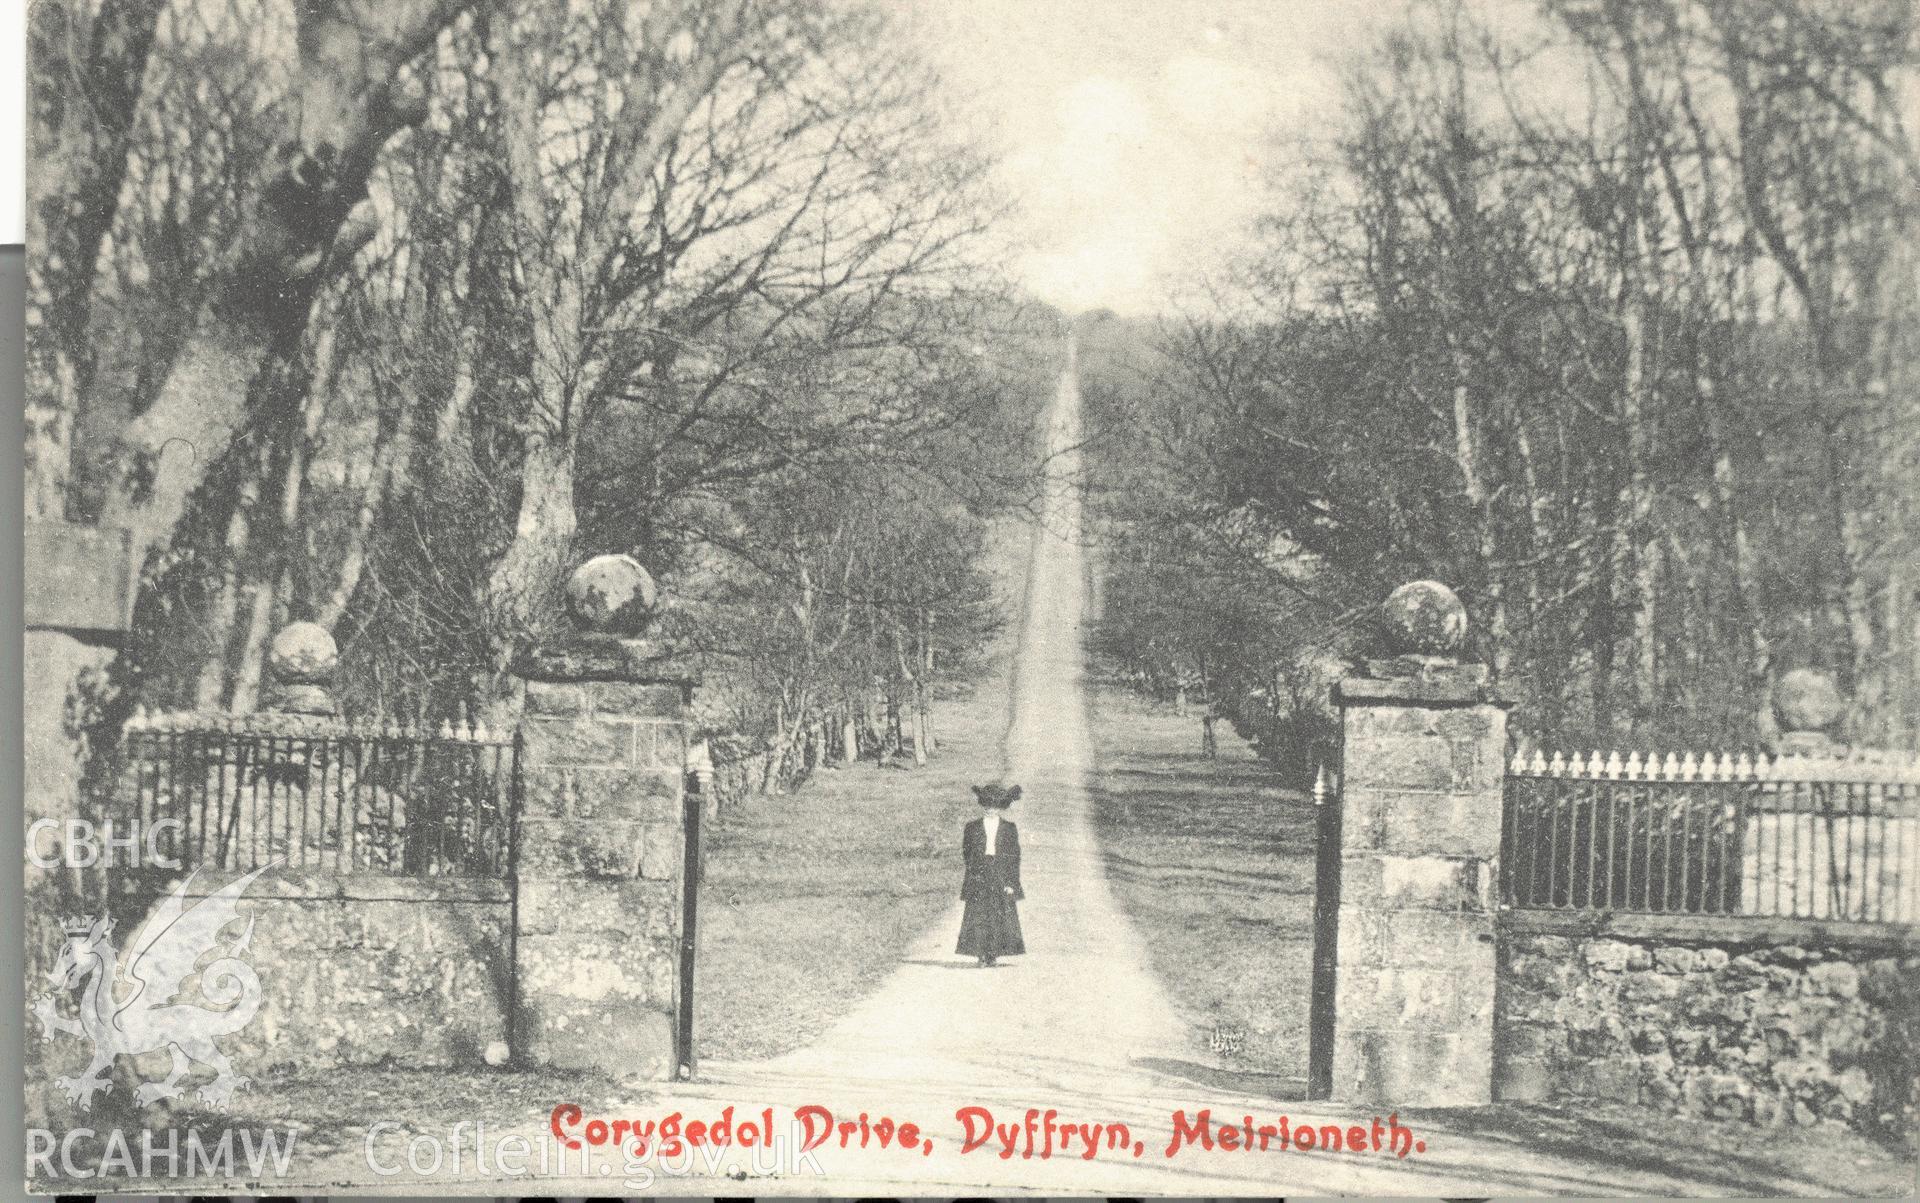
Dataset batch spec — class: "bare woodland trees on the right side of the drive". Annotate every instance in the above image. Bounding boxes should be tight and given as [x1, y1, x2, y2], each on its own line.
[1083, 0, 1920, 773]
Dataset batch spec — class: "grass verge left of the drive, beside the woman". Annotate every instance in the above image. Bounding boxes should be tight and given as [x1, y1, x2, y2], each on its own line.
[693, 524, 1031, 1061]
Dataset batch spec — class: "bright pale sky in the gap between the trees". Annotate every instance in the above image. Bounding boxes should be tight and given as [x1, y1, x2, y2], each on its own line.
[895, 0, 1400, 313]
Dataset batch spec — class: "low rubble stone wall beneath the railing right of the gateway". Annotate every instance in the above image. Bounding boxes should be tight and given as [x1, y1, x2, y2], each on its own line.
[1494, 911, 1920, 1147]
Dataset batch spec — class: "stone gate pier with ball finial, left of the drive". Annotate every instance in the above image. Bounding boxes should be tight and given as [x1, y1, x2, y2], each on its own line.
[513, 556, 693, 1078]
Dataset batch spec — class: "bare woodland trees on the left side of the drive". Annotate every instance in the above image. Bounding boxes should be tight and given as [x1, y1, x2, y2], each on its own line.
[27, 0, 1052, 783]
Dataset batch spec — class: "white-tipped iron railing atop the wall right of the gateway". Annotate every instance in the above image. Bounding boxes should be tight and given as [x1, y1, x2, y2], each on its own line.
[1500, 752, 1920, 923]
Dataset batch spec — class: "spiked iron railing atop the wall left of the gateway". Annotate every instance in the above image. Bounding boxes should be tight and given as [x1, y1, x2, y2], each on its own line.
[121, 712, 518, 877]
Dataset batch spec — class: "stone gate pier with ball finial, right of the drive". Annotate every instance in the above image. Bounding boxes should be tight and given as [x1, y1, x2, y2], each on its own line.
[1309, 581, 1507, 1107]
